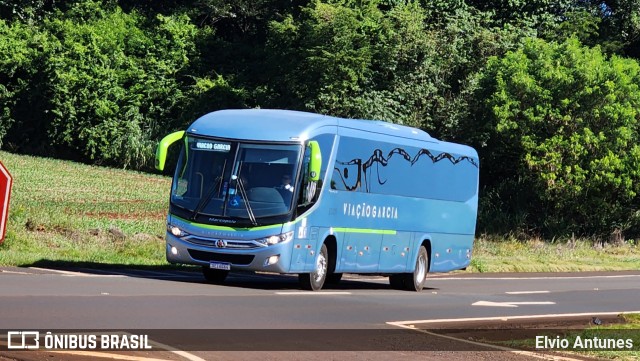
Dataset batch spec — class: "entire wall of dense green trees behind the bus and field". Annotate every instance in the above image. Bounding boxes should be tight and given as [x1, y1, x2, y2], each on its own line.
[0, 0, 640, 239]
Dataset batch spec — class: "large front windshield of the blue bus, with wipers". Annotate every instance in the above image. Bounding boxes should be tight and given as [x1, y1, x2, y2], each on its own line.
[171, 136, 302, 226]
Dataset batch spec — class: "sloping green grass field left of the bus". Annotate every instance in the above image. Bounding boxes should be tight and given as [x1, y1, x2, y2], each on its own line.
[0, 152, 171, 265]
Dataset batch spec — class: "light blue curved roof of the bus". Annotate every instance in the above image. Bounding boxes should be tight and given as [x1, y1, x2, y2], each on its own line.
[187, 109, 437, 142]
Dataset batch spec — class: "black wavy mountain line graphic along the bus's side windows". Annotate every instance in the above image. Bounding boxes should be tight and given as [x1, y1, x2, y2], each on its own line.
[334, 148, 478, 193]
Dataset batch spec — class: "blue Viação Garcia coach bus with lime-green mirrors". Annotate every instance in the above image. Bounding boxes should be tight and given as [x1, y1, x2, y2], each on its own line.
[156, 110, 479, 291]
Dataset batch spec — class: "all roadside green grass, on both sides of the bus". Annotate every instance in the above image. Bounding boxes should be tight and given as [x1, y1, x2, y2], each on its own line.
[0, 151, 640, 272]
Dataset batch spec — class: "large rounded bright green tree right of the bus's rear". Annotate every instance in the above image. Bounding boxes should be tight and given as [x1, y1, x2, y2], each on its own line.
[473, 39, 640, 236]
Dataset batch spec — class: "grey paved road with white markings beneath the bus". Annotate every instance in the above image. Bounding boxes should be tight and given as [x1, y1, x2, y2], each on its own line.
[0, 268, 640, 360]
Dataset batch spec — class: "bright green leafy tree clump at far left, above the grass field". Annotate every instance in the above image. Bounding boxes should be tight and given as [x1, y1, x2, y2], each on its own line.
[0, 0, 202, 168]
